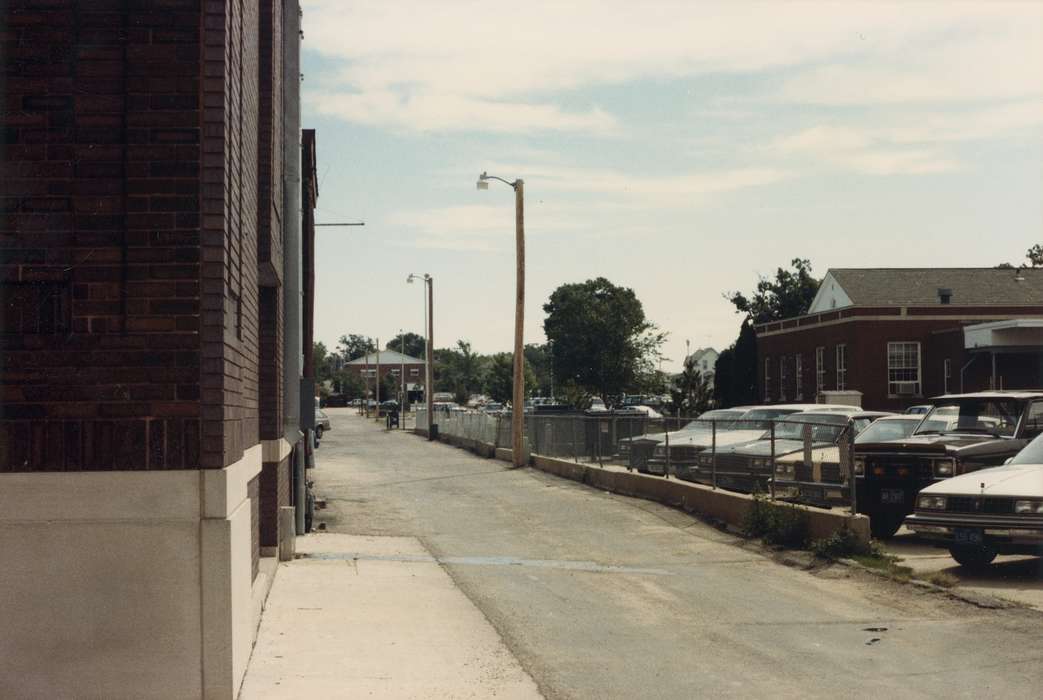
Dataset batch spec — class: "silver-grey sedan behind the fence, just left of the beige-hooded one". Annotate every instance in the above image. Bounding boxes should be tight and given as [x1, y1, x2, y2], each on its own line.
[695, 408, 883, 493]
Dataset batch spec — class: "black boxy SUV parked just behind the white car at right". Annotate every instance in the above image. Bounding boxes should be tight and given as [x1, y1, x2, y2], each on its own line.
[854, 391, 1043, 537]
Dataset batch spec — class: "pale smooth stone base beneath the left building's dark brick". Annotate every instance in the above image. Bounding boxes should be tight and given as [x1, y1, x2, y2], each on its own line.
[0, 444, 262, 698]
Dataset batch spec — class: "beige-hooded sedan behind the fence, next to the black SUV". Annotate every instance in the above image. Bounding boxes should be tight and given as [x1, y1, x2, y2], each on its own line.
[775, 413, 923, 508]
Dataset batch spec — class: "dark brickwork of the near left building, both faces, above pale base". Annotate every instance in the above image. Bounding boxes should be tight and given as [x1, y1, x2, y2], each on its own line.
[0, 0, 278, 470]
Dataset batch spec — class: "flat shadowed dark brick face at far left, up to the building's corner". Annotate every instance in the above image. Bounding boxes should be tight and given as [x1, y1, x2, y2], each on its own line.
[0, 0, 200, 470]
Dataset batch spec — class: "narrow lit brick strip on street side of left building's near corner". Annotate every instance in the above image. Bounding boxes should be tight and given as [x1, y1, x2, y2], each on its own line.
[200, 0, 259, 468]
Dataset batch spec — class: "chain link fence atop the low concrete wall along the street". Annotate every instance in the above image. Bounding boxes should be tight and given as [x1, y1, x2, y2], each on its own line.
[416, 409, 856, 513]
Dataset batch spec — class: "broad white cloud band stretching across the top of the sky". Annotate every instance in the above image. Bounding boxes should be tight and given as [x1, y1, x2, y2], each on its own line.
[305, 0, 1043, 135]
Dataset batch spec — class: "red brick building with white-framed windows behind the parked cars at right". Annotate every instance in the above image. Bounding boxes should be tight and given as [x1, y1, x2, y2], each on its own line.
[756, 268, 1043, 410]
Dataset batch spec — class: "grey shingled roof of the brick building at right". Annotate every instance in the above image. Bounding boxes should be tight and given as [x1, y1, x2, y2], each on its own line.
[829, 267, 1043, 306]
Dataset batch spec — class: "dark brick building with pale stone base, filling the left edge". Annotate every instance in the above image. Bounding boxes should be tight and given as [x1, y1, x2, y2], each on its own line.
[0, 0, 316, 698]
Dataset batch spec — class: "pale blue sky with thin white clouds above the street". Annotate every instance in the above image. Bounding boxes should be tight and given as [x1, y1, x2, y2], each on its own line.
[301, 0, 1043, 369]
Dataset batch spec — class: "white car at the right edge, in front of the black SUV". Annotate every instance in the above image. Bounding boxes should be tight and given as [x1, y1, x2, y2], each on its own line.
[905, 431, 1043, 569]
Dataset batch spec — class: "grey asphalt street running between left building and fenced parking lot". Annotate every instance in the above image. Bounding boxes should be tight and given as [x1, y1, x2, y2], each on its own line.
[312, 409, 1043, 698]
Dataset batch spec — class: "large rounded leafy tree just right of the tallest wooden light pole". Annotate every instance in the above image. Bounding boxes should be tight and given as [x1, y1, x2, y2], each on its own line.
[543, 277, 665, 399]
